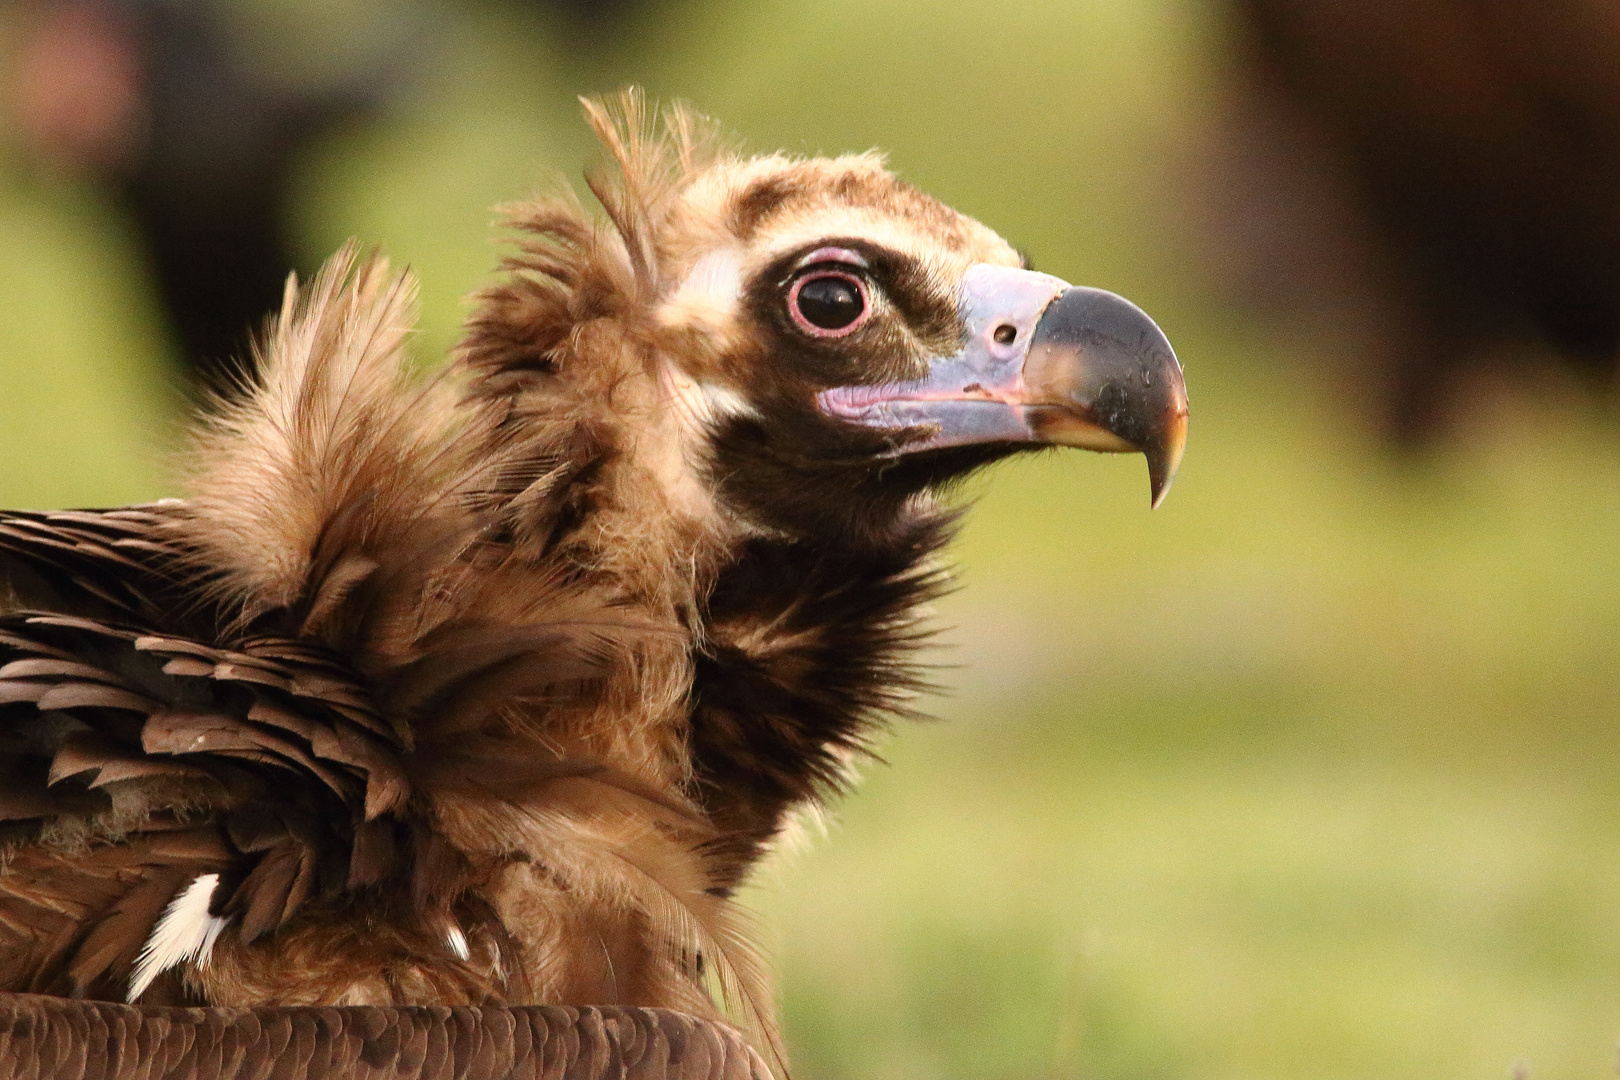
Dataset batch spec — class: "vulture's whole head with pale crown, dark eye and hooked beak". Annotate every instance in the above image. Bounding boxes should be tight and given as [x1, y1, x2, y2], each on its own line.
[467, 104, 1187, 547]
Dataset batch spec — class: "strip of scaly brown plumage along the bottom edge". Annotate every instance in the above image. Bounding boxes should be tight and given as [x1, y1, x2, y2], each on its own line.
[0, 994, 770, 1080]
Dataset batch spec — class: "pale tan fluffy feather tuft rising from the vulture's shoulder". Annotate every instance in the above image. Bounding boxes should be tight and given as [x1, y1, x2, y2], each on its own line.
[181, 243, 454, 617]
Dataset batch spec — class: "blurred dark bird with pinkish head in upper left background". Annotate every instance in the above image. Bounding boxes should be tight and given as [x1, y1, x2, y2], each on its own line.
[6, 0, 408, 390]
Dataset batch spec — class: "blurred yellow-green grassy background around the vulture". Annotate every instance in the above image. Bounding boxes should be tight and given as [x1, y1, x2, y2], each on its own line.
[0, 0, 1620, 1080]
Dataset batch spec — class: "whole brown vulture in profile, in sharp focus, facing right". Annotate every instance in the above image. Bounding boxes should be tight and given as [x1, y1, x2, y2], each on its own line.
[0, 94, 1187, 1080]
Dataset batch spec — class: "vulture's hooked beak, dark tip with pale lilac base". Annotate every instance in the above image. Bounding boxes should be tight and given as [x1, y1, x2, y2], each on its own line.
[816, 264, 1187, 507]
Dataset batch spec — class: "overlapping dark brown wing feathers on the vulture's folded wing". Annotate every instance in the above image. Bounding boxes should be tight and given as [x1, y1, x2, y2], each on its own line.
[0, 595, 408, 996]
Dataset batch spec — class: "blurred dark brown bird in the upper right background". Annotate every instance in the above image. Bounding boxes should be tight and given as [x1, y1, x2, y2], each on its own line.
[1234, 0, 1620, 442]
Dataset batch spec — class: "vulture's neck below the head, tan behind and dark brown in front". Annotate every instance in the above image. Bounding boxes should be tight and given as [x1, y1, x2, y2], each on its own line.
[463, 296, 954, 891]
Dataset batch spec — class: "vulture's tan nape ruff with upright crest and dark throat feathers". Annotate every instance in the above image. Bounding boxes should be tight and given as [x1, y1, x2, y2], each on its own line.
[457, 95, 956, 889]
